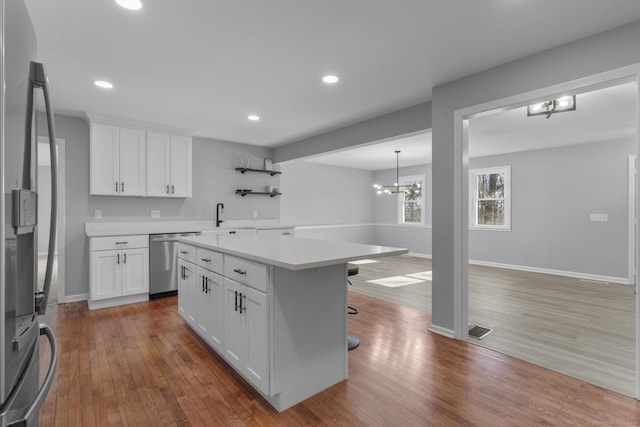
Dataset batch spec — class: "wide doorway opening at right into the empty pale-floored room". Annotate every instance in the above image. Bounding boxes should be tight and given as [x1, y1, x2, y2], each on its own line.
[456, 70, 638, 396]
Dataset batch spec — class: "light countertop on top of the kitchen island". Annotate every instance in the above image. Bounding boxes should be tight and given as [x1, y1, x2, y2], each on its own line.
[178, 234, 409, 270]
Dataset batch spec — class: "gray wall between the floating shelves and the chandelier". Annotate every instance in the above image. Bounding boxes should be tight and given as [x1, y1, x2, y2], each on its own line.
[280, 161, 375, 225]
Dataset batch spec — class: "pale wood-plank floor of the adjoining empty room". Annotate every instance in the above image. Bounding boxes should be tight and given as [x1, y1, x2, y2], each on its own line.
[350, 256, 635, 396]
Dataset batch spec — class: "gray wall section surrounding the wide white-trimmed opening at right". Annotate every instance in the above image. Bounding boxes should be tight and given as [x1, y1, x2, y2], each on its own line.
[432, 21, 640, 331]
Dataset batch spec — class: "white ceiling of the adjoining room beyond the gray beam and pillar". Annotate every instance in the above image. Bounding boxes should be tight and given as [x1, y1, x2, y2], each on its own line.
[306, 83, 637, 171]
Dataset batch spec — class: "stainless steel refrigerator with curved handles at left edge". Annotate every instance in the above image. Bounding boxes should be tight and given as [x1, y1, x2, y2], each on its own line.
[0, 0, 58, 427]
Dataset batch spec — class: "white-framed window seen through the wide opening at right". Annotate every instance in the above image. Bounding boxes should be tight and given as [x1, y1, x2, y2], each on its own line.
[469, 166, 511, 230]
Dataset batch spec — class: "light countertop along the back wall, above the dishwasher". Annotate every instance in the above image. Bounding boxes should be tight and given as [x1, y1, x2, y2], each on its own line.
[85, 220, 294, 237]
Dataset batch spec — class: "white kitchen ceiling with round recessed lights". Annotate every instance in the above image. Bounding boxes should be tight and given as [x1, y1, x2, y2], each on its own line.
[26, 0, 640, 147]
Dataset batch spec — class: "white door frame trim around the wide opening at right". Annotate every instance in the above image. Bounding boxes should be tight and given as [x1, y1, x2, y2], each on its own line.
[453, 64, 640, 398]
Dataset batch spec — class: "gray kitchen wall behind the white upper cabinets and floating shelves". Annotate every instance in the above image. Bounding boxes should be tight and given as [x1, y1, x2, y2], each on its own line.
[38, 115, 280, 296]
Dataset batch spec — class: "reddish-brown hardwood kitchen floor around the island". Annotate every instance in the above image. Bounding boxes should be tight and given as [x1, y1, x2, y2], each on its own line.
[40, 292, 640, 427]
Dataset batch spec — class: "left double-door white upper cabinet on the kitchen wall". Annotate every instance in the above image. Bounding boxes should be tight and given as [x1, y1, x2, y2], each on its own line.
[90, 123, 146, 196]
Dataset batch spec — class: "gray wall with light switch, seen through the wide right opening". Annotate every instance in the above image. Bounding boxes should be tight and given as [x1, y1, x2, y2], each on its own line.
[469, 140, 636, 278]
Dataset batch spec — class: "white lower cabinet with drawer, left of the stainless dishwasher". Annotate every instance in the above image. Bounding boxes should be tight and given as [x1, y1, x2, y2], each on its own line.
[89, 235, 149, 309]
